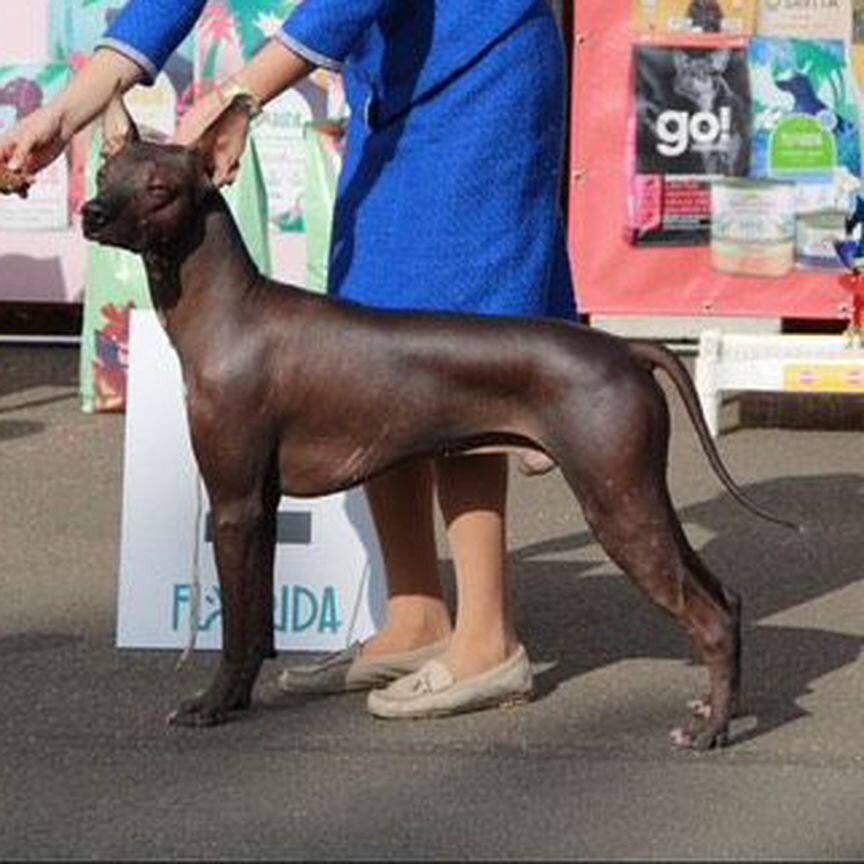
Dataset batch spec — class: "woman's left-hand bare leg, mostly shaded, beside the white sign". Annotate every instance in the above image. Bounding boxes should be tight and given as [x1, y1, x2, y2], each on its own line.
[363, 460, 451, 657]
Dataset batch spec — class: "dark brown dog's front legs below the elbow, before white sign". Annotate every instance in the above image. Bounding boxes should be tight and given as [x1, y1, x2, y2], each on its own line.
[168, 492, 279, 726]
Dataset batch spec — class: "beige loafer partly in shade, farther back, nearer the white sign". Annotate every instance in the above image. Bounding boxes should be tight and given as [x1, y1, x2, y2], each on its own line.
[276, 639, 448, 693]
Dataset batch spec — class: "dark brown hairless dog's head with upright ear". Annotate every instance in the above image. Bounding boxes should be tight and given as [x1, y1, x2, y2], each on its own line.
[82, 97, 215, 253]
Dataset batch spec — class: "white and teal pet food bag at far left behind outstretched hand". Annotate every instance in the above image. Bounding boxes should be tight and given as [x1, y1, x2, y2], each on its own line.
[0, 63, 71, 231]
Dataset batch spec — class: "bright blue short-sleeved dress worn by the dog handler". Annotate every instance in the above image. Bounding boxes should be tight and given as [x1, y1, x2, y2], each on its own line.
[100, 0, 576, 317]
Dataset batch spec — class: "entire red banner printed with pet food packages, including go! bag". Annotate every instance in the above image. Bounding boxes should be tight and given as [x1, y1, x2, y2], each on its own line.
[569, 0, 864, 318]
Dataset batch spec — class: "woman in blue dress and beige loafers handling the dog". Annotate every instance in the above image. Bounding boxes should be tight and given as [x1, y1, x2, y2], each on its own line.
[0, 0, 576, 717]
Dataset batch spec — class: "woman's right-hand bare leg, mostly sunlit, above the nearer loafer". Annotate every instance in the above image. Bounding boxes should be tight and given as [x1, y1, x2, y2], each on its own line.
[436, 455, 518, 680]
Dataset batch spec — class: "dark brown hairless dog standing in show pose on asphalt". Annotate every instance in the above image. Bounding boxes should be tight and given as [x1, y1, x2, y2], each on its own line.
[84, 99, 796, 748]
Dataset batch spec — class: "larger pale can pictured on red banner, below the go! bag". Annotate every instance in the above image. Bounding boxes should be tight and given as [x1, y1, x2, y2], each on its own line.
[711, 179, 795, 276]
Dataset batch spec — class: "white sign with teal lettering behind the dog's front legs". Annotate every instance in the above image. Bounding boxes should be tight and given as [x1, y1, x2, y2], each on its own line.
[117, 310, 386, 651]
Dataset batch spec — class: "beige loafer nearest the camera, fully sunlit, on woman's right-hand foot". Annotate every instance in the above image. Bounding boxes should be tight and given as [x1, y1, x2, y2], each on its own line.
[366, 645, 534, 720]
